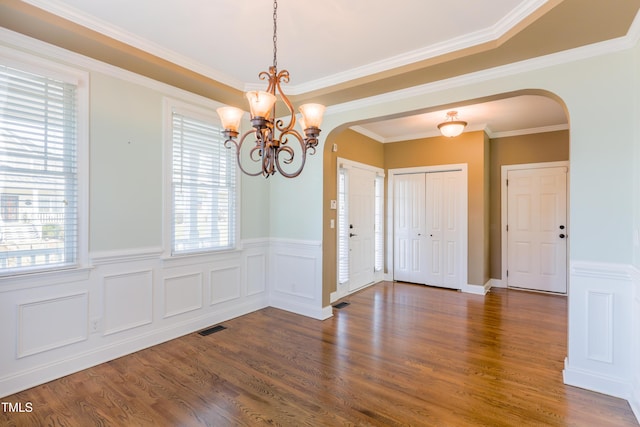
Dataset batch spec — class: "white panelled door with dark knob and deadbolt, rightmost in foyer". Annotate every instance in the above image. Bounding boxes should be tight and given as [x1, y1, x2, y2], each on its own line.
[507, 167, 568, 293]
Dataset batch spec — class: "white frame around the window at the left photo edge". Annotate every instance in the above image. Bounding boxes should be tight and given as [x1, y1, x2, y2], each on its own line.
[0, 46, 90, 284]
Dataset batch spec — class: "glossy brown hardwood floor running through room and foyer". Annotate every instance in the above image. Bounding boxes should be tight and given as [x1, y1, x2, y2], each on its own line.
[0, 282, 638, 426]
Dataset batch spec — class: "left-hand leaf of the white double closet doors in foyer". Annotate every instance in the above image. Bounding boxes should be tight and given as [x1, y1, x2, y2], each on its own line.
[393, 173, 427, 284]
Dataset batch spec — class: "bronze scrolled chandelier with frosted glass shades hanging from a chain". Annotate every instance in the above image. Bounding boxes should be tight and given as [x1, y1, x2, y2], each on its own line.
[216, 0, 325, 178]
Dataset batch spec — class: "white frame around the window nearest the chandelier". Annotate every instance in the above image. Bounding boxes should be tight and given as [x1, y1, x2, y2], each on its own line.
[162, 97, 242, 260]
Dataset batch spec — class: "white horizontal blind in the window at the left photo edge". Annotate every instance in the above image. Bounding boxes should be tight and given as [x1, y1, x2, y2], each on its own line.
[0, 65, 78, 275]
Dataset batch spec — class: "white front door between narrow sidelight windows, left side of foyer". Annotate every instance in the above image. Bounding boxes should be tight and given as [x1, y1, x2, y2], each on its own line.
[348, 168, 376, 291]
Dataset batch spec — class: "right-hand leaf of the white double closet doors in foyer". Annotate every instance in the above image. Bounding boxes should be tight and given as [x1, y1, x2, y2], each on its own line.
[425, 171, 464, 289]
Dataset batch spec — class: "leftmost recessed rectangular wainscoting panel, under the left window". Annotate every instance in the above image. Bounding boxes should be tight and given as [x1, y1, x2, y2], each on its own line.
[17, 292, 89, 358]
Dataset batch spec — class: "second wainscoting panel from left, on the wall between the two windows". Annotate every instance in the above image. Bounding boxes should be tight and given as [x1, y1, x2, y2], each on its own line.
[103, 270, 153, 335]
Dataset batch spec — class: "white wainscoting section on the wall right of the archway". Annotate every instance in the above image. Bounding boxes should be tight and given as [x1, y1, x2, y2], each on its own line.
[563, 262, 634, 399]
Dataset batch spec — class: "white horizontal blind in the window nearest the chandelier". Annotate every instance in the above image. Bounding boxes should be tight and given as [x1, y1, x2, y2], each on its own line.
[172, 111, 236, 255]
